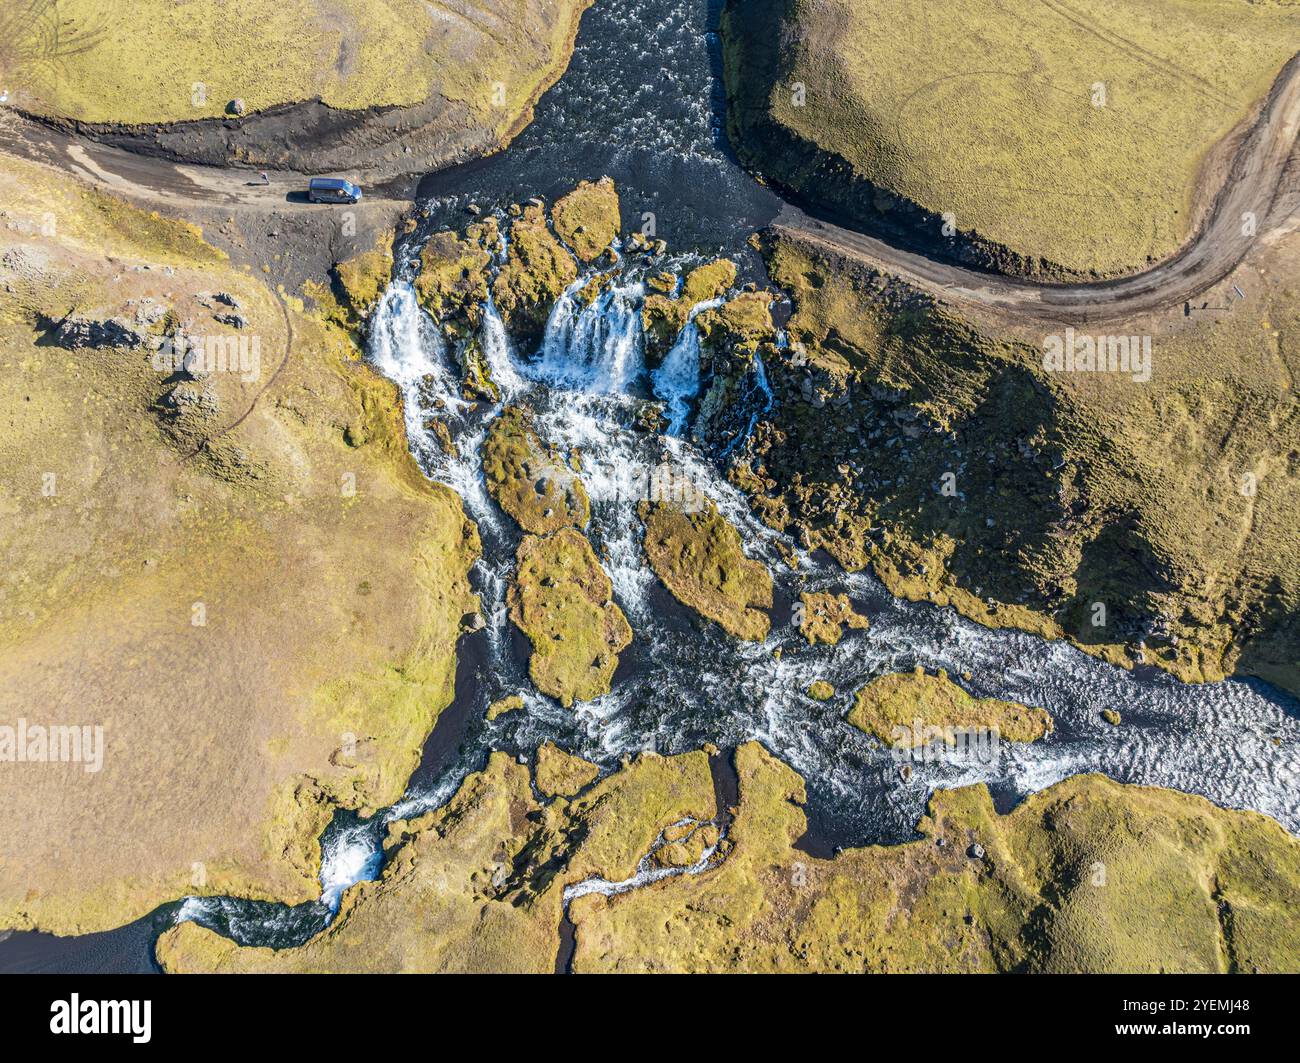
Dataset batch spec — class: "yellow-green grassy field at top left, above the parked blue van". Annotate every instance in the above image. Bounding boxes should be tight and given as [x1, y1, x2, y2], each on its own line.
[0, 0, 585, 127]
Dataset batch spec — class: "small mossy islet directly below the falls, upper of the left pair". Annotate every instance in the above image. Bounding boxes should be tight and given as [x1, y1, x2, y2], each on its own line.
[482, 407, 592, 535]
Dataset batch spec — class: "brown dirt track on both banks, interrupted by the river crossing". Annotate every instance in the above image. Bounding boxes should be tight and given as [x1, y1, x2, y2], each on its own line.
[0, 48, 1300, 322]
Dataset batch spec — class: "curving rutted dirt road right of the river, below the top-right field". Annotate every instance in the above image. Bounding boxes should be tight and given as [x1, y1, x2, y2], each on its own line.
[772, 55, 1300, 322]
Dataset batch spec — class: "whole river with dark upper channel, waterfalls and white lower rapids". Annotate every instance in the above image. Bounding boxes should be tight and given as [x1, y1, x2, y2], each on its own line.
[0, 0, 1300, 971]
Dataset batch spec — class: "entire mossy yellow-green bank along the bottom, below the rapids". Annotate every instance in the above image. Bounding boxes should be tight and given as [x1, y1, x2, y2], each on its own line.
[149, 742, 1300, 972]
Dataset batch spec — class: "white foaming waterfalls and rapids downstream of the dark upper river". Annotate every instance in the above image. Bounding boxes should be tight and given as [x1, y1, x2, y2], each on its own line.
[159, 248, 1300, 947]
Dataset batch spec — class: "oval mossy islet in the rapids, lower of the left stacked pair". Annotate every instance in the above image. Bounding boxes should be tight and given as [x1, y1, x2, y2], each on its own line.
[508, 528, 632, 707]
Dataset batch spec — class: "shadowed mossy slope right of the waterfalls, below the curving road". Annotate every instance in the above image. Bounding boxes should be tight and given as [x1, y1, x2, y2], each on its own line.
[733, 231, 1300, 689]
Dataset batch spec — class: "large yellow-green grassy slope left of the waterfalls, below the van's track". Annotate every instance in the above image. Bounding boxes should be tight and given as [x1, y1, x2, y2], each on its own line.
[0, 149, 477, 933]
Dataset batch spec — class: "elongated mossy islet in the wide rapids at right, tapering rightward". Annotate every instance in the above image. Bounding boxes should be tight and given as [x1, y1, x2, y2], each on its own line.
[848, 668, 1052, 749]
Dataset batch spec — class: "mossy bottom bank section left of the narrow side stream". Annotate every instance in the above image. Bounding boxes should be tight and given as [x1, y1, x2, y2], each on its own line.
[157, 752, 716, 973]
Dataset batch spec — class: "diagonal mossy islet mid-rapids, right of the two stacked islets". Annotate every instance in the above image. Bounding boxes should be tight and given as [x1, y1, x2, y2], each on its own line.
[638, 500, 772, 642]
